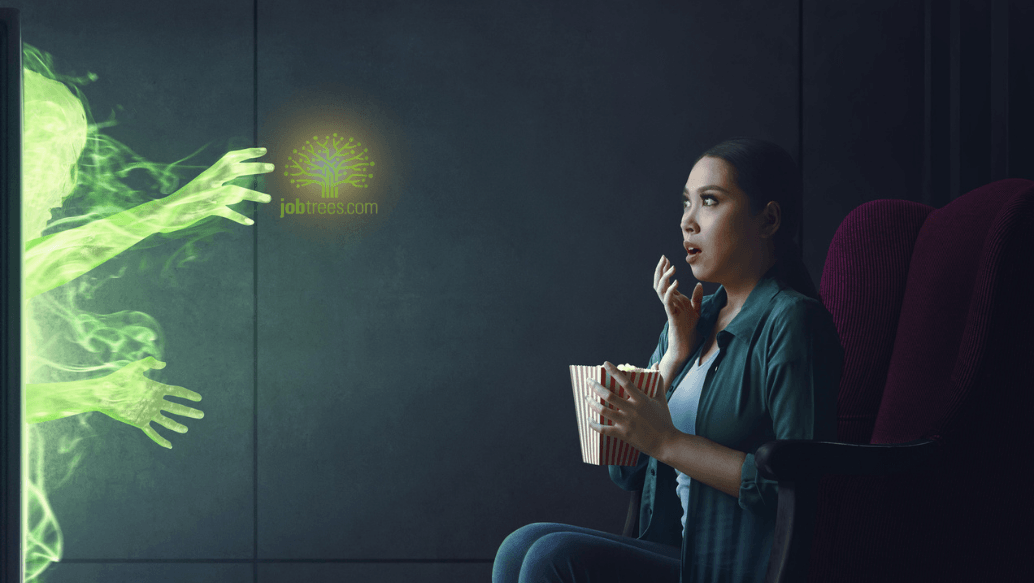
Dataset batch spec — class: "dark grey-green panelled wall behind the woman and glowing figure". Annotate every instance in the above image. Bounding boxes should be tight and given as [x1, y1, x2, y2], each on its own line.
[10, 0, 1031, 582]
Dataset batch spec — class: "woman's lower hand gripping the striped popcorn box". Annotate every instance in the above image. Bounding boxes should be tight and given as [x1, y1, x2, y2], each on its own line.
[586, 362, 678, 457]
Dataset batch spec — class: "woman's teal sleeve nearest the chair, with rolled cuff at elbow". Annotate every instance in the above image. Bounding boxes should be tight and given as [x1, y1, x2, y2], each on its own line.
[739, 300, 844, 514]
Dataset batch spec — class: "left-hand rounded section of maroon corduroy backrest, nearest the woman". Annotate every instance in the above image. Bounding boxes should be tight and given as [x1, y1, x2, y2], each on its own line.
[819, 200, 934, 443]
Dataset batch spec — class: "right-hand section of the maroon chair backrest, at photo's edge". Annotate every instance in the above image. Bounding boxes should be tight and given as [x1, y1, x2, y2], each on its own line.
[871, 180, 1034, 443]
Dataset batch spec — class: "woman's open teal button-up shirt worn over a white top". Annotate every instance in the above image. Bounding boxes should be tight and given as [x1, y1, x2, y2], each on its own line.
[609, 267, 844, 583]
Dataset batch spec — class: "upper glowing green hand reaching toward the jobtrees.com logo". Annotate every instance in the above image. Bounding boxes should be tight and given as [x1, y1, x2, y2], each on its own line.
[148, 148, 274, 233]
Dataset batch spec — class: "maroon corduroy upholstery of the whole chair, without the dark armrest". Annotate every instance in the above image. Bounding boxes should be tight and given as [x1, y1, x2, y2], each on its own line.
[808, 180, 1034, 582]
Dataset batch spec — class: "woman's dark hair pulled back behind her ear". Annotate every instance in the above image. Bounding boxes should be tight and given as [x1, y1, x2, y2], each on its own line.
[693, 137, 822, 302]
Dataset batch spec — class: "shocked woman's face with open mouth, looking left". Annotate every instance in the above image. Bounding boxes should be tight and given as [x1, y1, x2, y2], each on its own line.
[681, 156, 765, 285]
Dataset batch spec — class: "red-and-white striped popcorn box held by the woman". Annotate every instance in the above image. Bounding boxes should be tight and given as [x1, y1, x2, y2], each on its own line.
[571, 365, 661, 465]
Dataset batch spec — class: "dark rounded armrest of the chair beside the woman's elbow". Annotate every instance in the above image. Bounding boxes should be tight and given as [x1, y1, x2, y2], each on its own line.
[754, 438, 943, 479]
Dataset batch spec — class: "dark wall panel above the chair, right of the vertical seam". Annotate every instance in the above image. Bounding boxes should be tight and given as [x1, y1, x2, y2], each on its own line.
[801, 0, 931, 284]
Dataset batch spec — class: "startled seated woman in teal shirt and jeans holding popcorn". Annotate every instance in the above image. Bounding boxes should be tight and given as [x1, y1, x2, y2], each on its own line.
[492, 139, 844, 583]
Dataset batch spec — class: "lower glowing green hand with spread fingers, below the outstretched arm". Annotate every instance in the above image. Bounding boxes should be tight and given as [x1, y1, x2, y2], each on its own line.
[94, 357, 205, 449]
